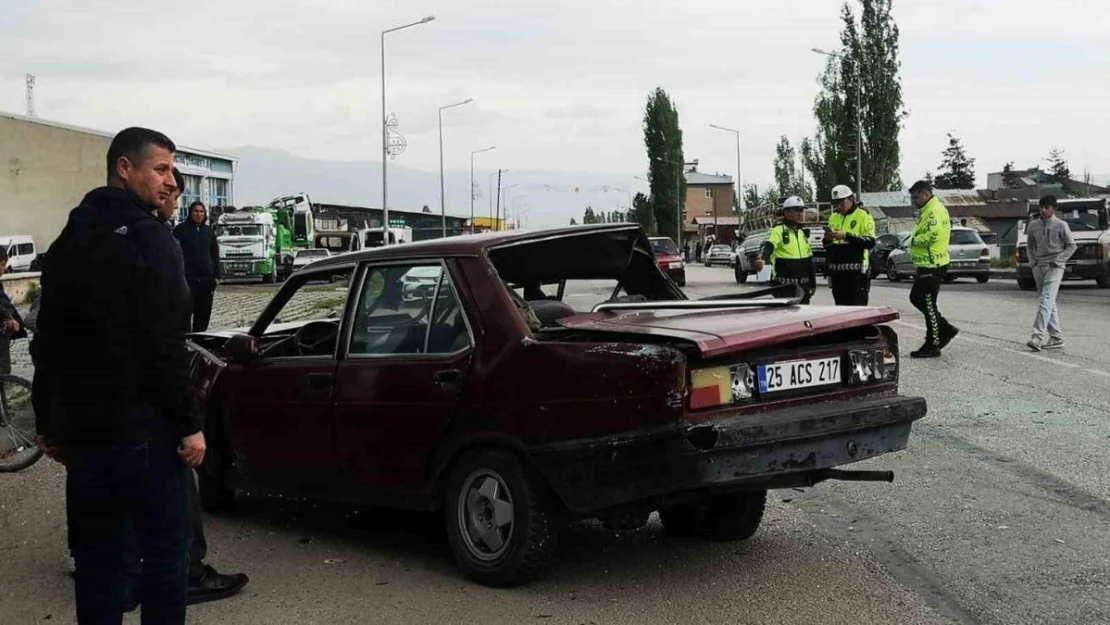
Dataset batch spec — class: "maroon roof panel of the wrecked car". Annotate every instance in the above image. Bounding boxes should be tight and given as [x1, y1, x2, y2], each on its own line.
[312, 223, 639, 270]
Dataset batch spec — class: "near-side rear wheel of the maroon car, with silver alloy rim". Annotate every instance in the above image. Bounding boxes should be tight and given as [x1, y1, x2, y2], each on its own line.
[444, 448, 559, 587]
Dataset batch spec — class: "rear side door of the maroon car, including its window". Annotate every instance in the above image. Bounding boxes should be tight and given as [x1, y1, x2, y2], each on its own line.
[334, 260, 474, 492]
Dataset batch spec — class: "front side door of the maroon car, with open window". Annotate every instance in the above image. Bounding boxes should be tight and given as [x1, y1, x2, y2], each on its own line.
[221, 265, 354, 490]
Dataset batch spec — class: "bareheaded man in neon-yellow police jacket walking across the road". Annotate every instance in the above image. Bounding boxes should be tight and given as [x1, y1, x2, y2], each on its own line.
[909, 180, 960, 359]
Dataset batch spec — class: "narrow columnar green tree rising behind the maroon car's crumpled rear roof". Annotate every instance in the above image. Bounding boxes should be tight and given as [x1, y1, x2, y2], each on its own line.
[644, 87, 686, 242]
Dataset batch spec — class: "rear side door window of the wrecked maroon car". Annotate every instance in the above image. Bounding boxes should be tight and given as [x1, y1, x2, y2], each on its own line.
[350, 264, 471, 356]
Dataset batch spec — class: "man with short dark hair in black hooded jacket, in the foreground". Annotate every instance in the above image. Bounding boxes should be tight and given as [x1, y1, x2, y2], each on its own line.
[32, 128, 205, 624]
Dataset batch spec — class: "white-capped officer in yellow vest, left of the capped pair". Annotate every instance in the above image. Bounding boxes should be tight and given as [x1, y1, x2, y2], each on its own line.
[755, 195, 817, 304]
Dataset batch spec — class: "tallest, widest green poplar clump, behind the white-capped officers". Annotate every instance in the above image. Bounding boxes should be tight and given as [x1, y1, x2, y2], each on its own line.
[801, 0, 906, 201]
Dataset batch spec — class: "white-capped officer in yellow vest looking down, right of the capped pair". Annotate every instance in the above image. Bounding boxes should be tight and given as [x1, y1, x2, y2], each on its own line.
[825, 184, 875, 306]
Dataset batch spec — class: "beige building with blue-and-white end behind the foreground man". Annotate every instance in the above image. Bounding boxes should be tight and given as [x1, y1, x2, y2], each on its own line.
[0, 111, 236, 250]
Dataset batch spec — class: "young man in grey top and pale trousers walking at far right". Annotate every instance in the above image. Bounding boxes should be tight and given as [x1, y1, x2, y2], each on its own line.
[1026, 195, 1076, 352]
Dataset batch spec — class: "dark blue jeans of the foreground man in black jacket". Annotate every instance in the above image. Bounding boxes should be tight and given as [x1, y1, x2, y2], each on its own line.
[65, 435, 189, 625]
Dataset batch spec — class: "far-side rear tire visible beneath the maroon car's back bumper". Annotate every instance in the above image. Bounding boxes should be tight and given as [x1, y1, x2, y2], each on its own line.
[659, 491, 767, 541]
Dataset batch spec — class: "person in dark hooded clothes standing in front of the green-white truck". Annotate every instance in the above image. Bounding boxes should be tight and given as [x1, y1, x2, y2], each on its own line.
[173, 201, 220, 332]
